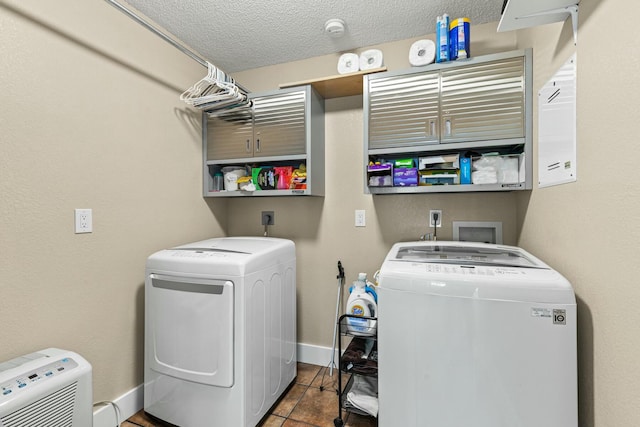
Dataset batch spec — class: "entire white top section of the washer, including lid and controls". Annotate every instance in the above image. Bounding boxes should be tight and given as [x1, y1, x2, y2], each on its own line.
[378, 241, 575, 305]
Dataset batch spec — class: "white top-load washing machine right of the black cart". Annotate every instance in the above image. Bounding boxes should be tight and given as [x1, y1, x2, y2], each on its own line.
[378, 242, 578, 427]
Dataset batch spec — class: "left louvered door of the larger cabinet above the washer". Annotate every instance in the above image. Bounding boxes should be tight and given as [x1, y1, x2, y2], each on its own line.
[364, 71, 439, 150]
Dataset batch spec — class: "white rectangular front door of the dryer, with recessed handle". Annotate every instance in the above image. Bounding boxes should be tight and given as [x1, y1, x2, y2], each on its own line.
[146, 274, 233, 387]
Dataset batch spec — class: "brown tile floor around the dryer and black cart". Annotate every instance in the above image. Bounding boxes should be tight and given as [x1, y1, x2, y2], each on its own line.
[122, 363, 378, 427]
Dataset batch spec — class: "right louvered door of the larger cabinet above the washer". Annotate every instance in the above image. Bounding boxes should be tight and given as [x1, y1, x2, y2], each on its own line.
[440, 57, 525, 143]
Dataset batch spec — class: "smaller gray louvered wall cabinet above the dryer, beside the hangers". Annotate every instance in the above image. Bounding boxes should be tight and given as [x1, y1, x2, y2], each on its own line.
[202, 85, 324, 197]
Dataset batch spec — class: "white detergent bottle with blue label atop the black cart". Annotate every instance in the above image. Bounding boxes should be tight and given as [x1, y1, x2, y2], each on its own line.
[346, 273, 378, 335]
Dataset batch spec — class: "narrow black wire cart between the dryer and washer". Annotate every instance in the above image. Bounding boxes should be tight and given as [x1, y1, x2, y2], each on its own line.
[333, 314, 378, 427]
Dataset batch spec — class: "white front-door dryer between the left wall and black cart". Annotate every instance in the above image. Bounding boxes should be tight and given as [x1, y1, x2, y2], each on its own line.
[144, 237, 297, 427]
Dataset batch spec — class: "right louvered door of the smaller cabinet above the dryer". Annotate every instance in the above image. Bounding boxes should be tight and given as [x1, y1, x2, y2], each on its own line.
[253, 90, 307, 157]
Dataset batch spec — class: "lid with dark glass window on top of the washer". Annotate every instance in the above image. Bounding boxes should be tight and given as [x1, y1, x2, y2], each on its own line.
[387, 242, 549, 268]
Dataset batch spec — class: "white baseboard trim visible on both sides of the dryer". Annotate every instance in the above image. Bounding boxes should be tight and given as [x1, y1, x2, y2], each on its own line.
[93, 343, 337, 427]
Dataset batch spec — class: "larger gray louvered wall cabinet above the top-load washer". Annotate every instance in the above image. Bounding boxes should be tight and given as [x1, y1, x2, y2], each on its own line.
[363, 49, 533, 194]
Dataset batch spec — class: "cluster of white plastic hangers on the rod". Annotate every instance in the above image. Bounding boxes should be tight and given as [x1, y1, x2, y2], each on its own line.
[180, 62, 251, 115]
